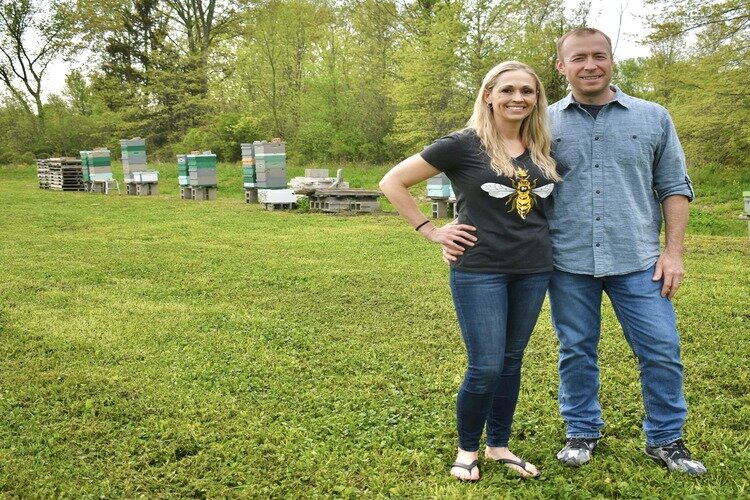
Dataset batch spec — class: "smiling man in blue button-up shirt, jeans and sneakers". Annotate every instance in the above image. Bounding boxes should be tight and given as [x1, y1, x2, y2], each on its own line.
[548, 28, 706, 475]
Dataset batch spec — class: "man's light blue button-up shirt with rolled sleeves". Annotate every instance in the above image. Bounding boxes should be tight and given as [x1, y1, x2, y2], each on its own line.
[547, 86, 693, 277]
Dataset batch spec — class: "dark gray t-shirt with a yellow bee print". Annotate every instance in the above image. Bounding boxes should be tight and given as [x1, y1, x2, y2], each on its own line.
[421, 129, 554, 274]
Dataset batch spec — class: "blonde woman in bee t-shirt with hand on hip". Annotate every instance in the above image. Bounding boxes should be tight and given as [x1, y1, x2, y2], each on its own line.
[380, 61, 560, 481]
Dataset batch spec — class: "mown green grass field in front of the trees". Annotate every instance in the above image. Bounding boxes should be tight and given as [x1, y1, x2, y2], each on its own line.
[0, 165, 750, 498]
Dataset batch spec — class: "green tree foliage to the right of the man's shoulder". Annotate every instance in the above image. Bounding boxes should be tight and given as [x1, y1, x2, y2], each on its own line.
[648, 0, 750, 168]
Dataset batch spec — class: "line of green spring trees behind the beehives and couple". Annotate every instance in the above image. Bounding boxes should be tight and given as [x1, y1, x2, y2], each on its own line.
[0, 0, 750, 167]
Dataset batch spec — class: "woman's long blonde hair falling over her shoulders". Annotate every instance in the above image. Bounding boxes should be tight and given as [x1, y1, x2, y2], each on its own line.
[466, 61, 560, 181]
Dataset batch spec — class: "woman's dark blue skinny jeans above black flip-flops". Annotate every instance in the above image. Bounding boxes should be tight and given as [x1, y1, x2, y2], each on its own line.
[450, 270, 551, 451]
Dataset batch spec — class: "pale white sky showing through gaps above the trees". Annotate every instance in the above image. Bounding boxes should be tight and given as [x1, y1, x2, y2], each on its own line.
[36, 0, 649, 99]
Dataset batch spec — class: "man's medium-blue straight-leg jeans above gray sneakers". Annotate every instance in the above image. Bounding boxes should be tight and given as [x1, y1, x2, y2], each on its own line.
[549, 267, 687, 446]
